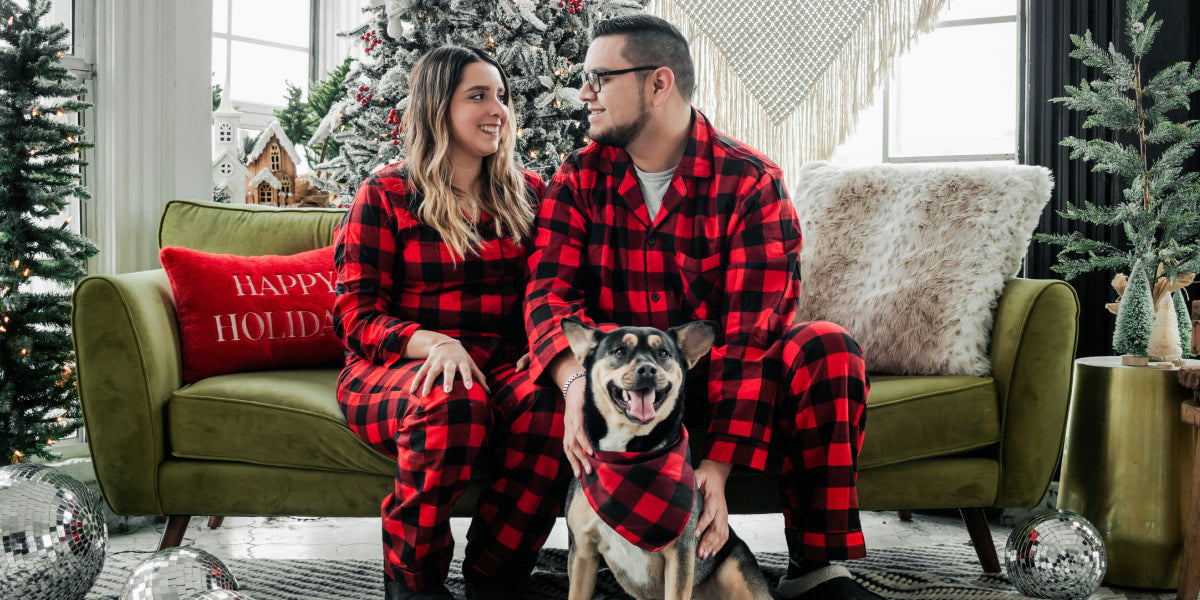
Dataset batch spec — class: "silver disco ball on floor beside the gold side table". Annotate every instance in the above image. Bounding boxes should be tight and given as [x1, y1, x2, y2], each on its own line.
[1004, 510, 1109, 600]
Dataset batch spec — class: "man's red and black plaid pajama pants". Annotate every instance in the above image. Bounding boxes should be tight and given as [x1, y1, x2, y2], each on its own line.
[689, 320, 869, 560]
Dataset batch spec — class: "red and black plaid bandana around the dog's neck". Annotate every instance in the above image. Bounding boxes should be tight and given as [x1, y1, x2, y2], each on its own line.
[583, 430, 696, 552]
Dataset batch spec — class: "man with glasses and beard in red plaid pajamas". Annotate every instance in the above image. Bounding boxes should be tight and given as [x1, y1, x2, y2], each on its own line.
[524, 14, 877, 599]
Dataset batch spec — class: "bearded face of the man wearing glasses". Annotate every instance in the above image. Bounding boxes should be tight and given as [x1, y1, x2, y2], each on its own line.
[580, 36, 650, 148]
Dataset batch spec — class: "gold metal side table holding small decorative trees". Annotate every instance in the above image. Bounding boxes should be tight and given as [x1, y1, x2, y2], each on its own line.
[1058, 356, 1200, 589]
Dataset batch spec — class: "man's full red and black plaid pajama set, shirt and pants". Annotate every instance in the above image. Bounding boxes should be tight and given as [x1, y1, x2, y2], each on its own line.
[524, 110, 869, 560]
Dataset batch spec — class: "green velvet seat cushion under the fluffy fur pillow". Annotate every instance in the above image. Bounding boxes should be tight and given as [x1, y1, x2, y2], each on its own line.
[858, 374, 1000, 470]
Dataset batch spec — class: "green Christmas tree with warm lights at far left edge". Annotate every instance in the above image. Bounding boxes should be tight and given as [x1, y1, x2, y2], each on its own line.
[0, 0, 96, 461]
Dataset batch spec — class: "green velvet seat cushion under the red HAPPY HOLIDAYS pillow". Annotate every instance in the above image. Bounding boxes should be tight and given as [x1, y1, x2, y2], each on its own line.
[167, 368, 396, 476]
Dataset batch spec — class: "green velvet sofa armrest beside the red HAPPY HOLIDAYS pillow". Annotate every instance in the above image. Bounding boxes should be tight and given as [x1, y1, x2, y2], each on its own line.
[71, 270, 182, 515]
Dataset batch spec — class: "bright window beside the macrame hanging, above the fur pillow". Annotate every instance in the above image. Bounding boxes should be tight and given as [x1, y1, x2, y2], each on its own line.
[833, 0, 1020, 164]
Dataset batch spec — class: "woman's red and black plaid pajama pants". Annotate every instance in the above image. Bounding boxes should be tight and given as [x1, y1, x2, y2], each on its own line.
[338, 352, 570, 590]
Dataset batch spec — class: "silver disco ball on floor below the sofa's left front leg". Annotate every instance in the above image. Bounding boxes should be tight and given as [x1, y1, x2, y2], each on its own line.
[121, 546, 245, 600]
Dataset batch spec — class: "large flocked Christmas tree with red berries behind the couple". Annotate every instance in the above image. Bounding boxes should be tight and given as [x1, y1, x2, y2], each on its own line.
[308, 0, 647, 203]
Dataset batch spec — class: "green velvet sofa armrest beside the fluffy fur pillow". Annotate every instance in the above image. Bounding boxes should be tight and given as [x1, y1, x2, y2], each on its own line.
[991, 278, 1079, 508]
